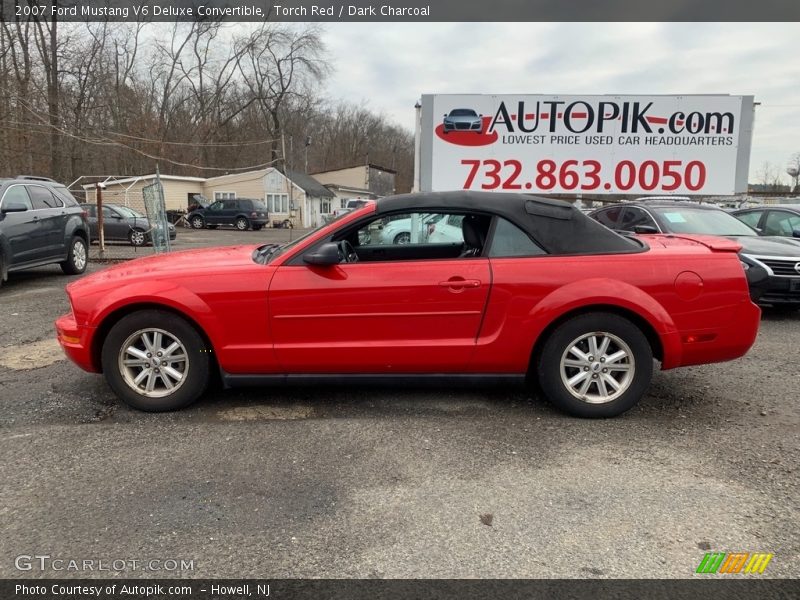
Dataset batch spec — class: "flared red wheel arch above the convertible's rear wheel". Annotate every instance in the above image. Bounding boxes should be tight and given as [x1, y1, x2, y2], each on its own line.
[529, 277, 681, 369]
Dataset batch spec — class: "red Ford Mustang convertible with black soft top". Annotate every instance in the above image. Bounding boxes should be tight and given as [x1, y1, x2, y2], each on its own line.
[56, 192, 760, 417]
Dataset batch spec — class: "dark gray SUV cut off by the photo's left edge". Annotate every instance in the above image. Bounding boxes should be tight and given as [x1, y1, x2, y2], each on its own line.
[0, 175, 89, 284]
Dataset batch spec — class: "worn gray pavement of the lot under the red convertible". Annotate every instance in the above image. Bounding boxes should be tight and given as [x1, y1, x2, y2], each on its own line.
[0, 230, 800, 578]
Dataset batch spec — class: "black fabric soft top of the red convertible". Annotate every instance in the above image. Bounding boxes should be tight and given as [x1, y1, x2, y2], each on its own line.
[376, 191, 643, 254]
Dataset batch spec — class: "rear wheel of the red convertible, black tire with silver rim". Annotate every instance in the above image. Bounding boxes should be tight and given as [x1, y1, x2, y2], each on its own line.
[534, 312, 653, 418]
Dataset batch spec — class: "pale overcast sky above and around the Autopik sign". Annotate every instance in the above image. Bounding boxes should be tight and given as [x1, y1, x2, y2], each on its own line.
[324, 23, 800, 183]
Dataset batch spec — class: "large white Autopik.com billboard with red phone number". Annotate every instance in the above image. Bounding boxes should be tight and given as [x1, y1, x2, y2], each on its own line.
[418, 94, 753, 195]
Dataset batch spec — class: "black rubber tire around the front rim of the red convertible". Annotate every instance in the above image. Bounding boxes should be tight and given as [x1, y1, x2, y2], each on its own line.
[101, 310, 211, 412]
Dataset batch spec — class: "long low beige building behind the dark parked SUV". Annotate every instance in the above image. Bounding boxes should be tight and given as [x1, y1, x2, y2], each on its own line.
[82, 167, 335, 228]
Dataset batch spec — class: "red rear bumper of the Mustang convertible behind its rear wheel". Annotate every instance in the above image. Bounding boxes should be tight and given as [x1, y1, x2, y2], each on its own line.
[672, 301, 761, 367]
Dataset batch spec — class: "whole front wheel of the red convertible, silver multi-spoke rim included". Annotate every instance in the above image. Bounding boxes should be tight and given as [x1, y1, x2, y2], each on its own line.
[101, 310, 210, 412]
